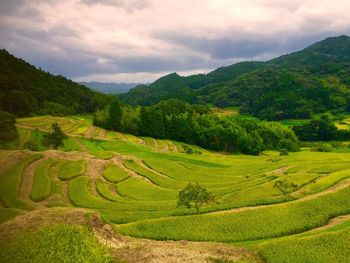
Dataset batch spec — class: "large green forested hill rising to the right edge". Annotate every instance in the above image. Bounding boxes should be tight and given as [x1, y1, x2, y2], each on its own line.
[121, 36, 350, 119]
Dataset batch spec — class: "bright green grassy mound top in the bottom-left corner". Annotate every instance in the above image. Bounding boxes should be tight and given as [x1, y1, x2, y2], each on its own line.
[0, 225, 111, 263]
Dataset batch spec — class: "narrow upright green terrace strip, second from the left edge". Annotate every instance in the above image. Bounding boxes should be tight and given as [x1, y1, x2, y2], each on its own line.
[29, 159, 55, 202]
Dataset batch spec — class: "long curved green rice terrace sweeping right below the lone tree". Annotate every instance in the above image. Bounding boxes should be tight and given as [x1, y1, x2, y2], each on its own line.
[119, 187, 350, 242]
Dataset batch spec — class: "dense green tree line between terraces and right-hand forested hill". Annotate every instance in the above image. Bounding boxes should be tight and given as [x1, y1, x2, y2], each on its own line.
[93, 99, 298, 155]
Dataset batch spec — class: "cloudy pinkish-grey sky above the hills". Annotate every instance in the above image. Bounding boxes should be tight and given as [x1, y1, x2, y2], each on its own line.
[0, 0, 350, 82]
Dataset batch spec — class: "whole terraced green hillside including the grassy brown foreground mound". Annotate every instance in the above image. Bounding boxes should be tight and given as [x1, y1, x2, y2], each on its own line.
[0, 116, 350, 263]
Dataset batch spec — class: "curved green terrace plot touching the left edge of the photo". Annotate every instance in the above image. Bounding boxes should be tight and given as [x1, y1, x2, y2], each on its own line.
[0, 154, 41, 209]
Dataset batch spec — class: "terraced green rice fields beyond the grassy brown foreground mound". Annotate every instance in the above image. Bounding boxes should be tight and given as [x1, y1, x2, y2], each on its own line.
[0, 116, 350, 262]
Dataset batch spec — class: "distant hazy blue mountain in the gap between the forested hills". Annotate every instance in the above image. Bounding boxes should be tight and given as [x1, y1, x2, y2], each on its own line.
[79, 82, 141, 94]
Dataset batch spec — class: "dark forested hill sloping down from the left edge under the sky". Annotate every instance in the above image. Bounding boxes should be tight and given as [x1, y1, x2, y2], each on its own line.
[0, 50, 109, 116]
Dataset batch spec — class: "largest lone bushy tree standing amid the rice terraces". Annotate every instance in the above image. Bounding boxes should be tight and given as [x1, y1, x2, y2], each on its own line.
[177, 183, 213, 214]
